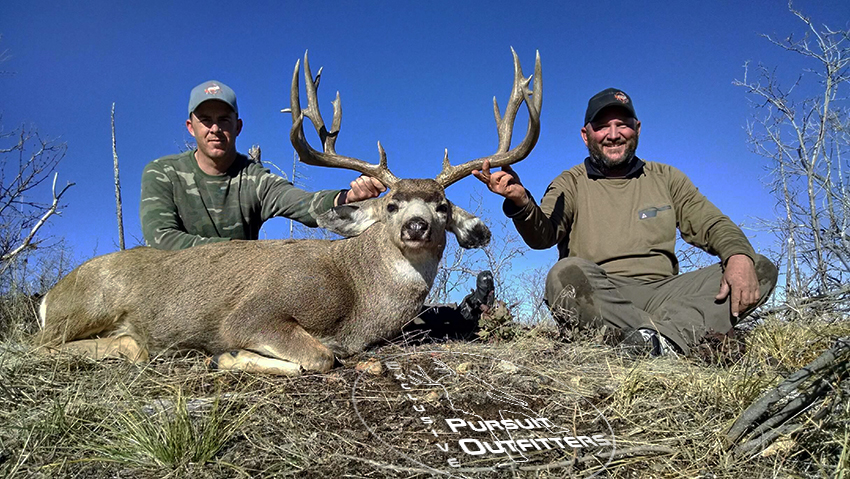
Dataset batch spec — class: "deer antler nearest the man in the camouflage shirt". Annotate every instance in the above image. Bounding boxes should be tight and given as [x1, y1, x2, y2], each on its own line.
[281, 52, 399, 188]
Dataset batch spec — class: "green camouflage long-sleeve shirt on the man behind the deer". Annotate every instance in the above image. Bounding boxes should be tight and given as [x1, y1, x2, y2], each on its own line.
[139, 150, 340, 249]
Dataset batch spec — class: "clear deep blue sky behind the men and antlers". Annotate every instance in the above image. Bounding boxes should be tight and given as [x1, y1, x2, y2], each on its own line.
[0, 0, 850, 276]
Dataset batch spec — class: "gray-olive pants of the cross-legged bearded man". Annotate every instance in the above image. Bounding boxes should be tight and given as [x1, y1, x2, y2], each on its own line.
[544, 255, 777, 354]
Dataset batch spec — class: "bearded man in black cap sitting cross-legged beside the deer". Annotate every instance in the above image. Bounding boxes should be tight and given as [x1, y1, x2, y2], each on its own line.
[473, 88, 777, 355]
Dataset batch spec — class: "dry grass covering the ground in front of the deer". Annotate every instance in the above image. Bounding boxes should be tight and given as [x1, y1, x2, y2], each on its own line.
[0, 310, 850, 479]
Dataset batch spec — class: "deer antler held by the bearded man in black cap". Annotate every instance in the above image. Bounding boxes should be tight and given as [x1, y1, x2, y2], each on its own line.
[436, 47, 543, 188]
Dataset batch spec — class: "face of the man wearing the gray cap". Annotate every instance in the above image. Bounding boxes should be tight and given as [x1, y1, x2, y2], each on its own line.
[186, 100, 242, 161]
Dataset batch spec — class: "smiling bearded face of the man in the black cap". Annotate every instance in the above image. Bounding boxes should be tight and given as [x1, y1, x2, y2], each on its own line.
[581, 107, 640, 170]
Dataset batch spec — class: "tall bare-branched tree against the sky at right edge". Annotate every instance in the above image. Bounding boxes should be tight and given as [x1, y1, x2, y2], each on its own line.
[733, 3, 850, 300]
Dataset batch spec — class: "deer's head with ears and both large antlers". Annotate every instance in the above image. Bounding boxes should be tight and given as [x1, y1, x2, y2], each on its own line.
[283, 48, 543, 252]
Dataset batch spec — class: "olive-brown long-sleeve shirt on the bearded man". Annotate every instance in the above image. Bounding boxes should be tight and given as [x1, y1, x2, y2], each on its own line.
[504, 158, 755, 281]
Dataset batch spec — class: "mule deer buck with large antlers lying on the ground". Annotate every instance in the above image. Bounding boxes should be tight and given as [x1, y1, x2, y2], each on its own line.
[36, 49, 542, 375]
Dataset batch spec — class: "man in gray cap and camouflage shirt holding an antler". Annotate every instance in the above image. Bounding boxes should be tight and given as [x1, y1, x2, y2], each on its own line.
[140, 80, 386, 249]
